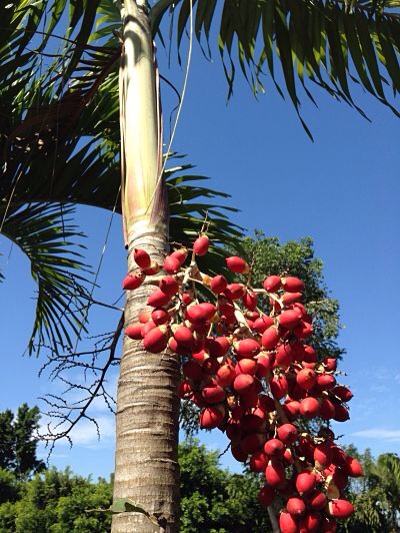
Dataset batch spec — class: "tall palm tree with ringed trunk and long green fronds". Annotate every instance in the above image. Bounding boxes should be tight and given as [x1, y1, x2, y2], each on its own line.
[0, 0, 400, 533]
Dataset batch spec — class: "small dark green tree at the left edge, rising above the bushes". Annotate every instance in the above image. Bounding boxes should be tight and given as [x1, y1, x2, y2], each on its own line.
[0, 403, 45, 479]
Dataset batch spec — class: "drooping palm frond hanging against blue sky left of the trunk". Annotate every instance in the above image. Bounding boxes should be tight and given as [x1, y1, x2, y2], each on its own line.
[1, 204, 88, 354]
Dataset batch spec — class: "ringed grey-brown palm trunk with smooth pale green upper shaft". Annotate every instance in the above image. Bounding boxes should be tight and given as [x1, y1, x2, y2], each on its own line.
[112, 0, 179, 533]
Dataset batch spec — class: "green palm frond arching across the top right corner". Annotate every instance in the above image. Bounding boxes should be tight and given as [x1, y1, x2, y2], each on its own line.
[151, 0, 400, 133]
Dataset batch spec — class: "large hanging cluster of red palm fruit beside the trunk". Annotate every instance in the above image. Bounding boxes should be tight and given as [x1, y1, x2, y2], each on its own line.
[123, 235, 362, 533]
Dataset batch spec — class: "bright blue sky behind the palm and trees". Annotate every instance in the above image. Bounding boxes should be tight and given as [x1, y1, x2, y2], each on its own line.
[0, 25, 400, 476]
